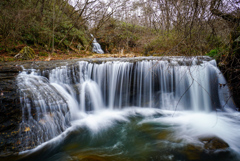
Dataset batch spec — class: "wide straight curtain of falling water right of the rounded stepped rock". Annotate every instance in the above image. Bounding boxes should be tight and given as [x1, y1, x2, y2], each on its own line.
[45, 58, 232, 111]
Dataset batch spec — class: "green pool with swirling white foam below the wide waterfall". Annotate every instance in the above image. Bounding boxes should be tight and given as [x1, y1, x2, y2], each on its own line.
[10, 107, 240, 161]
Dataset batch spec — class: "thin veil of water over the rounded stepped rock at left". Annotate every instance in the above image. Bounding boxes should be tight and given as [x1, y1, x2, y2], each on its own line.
[17, 72, 74, 147]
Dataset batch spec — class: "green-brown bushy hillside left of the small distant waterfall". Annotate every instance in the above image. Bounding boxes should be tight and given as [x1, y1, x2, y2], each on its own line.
[0, 0, 88, 52]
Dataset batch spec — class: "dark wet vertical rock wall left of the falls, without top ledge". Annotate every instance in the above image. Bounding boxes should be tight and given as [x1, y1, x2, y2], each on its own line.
[0, 64, 22, 156]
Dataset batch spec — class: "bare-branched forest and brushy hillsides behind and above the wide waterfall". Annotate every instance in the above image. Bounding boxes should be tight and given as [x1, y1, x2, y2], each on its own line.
[0, 0, 240, 109]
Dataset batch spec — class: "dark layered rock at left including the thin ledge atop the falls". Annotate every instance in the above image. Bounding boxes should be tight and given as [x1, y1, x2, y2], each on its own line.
[0, 61, 74, 156]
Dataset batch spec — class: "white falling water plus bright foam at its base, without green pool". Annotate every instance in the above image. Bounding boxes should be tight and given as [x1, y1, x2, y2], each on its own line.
[15, 57, 240, 158]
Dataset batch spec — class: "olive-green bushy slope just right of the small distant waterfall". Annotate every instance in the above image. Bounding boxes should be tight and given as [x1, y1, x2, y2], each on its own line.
[97, 19, 151, 53]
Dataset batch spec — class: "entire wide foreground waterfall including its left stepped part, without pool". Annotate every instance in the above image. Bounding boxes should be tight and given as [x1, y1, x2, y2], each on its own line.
[17, 57, 234, 152]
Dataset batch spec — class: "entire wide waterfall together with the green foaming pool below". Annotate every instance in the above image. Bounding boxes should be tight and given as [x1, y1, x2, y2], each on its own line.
[17, 57, 240, 160]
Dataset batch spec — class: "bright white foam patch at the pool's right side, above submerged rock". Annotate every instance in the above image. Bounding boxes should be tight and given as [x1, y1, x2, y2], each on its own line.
[142, 111, 240, 152]
